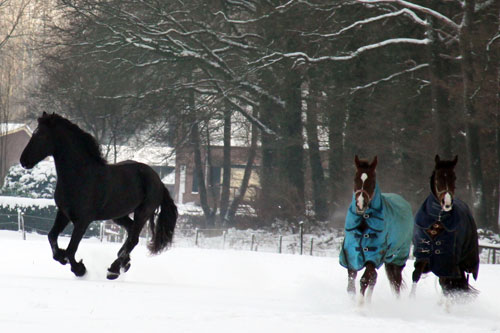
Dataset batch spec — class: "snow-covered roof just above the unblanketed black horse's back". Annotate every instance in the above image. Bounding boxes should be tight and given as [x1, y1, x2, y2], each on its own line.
[102, 146, 175, 167]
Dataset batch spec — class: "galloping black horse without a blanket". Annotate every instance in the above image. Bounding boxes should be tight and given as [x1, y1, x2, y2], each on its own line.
[21, 112, 177, 279]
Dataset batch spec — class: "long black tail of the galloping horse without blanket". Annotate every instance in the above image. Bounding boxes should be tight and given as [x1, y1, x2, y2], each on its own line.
[148, 187, 177, 254]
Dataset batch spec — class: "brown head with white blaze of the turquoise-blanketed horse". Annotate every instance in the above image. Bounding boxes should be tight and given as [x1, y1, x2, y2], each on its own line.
[354, 155, 377, 215]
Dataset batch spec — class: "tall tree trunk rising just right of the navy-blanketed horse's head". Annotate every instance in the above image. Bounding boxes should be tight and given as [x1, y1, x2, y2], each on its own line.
[459, 0, 491, 227]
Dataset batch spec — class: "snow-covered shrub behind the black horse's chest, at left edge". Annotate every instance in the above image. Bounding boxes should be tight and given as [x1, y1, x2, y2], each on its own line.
[0, 161, 57, 198]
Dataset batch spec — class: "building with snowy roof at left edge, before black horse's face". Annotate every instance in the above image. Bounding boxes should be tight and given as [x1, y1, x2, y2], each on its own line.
[0, 123, 33, 187]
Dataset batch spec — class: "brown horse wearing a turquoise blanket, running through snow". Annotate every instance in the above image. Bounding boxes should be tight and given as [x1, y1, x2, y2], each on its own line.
[340, 156, 413, 303]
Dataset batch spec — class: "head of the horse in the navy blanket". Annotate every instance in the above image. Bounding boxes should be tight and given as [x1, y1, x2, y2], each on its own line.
[431, 155, 458, 212]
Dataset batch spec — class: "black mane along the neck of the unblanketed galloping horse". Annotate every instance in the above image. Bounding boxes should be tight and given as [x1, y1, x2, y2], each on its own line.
[38, 113, 107, 165]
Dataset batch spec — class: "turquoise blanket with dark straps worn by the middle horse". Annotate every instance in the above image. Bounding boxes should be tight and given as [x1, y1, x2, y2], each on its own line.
[339, 184, 413, 271]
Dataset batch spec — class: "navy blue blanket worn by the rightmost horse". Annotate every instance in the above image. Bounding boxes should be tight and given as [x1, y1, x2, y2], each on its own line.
[413, 194, 479, 279]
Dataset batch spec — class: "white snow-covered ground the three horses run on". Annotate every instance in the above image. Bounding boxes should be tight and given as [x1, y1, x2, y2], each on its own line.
[0, 231, 500, 333]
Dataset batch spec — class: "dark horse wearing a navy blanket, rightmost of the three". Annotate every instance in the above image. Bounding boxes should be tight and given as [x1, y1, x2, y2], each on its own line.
[411, 155, 479, 296]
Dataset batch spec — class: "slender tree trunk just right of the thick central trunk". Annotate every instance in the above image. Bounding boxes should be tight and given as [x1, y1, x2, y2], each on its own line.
[305, 78, 328, 221]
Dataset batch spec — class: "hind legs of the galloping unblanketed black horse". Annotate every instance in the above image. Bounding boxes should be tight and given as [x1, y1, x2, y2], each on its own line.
[107, 210, 146, 280]
